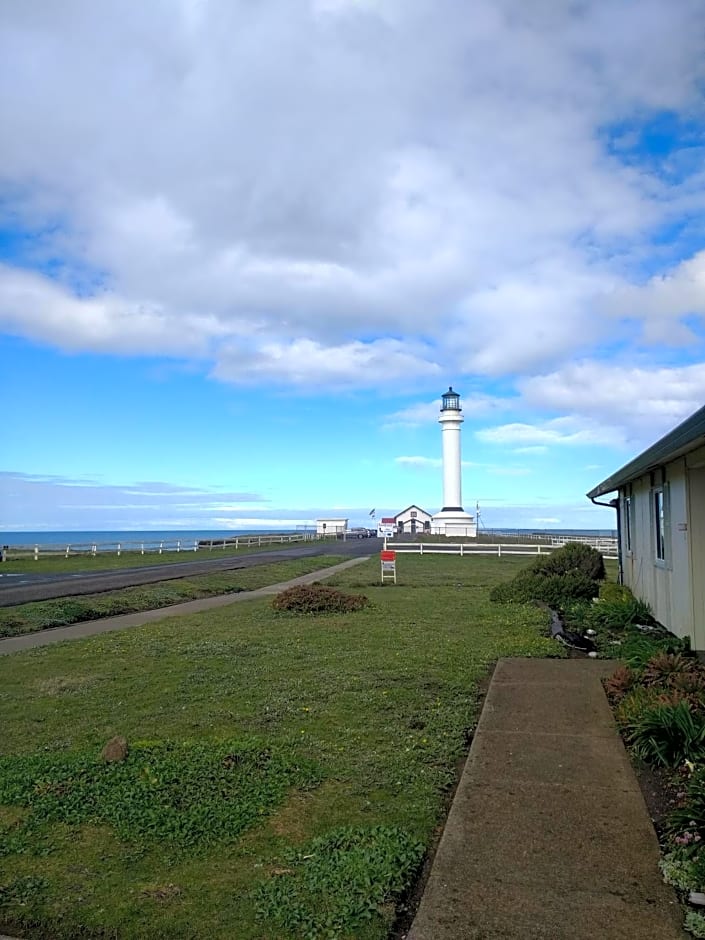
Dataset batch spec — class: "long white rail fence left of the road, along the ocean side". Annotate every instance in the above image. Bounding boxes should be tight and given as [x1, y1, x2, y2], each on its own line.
[0, 532, 326, 561]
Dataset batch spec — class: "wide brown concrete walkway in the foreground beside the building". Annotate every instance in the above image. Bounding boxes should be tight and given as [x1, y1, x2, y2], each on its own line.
[408, 659, 688, 940]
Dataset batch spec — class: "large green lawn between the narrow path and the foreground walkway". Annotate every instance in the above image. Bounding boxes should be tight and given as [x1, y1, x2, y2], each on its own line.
[0, 556, 557, 940]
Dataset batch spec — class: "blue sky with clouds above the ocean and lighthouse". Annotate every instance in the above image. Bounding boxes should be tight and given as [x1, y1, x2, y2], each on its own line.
[0, 0, 705, 531]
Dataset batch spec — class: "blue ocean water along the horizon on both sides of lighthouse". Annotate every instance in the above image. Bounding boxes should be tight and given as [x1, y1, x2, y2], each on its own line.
[0, 525, 617, 547]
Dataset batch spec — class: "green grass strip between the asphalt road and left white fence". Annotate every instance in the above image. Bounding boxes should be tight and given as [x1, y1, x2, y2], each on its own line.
[0, 538, 336, 574]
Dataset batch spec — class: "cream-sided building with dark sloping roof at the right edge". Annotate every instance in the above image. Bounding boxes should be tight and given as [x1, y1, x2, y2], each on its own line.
[587, 407, 705, 652]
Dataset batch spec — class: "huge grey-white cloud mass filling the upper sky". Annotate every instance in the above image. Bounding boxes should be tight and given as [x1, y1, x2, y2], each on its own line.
[0, 0, 705, 390]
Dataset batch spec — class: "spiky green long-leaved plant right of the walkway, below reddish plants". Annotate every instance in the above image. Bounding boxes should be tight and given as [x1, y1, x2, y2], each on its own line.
[625, 701, 705, 767]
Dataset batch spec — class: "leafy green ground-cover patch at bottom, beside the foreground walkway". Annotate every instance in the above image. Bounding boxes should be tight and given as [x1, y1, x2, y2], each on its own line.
[255, 826, 424, 940]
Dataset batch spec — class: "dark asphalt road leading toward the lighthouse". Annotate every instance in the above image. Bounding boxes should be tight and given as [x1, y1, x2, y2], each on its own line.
[0, 538, 382, 607]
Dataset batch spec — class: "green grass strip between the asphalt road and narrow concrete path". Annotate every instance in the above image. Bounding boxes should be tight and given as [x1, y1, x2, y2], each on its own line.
[0, 555, 345, 637]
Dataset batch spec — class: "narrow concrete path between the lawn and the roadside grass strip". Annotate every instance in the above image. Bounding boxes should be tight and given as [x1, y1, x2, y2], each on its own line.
[0, 556, 369, 652]
